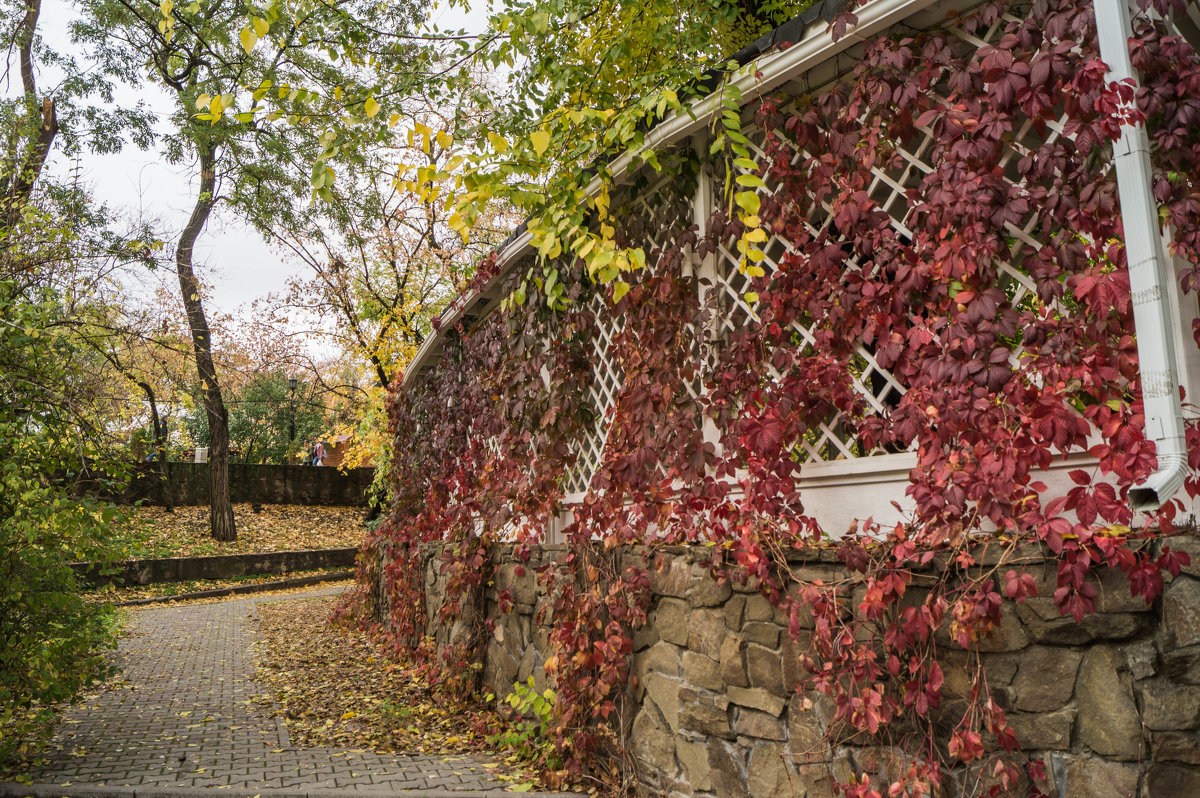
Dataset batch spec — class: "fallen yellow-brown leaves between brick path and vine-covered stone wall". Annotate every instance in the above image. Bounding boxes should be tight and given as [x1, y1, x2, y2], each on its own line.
[257, 596, 544, 791]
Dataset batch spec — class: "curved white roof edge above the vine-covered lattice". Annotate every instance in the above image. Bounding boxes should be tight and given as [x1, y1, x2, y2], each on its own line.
[401, 0, 940, 385]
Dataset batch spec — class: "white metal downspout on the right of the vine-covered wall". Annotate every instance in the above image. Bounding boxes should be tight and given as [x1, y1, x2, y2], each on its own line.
[1093, 0, 1188, 510]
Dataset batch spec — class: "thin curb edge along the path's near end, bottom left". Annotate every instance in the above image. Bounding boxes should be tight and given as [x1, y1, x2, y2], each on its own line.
[0, 781, 584, 798]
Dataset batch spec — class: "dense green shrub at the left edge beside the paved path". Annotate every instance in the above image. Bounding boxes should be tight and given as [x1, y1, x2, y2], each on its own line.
[0, 281, 122, 769]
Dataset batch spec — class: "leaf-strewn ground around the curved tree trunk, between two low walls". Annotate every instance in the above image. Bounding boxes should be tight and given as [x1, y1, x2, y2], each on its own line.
[114, 504, 366, 559]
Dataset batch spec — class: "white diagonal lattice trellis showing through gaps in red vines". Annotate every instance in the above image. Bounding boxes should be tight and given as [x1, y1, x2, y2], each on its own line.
[492, 3, 1094, 496]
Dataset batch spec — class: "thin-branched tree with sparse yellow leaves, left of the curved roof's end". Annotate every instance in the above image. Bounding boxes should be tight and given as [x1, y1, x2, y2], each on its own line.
[271, 98, 521, 390]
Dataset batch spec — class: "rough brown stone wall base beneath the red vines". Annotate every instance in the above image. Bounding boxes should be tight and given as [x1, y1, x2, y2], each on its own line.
[412, 538, 1200, 798]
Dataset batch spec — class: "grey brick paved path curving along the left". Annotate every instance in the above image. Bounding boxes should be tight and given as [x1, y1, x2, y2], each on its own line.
[17, 588, 516, 791]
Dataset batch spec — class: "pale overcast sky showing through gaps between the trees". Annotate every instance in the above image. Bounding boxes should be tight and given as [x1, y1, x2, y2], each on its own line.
[38, 0, 487, 313]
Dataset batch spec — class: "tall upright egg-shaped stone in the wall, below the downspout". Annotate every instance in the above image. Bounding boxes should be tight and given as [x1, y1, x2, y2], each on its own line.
[1075, 647, 1141, 760]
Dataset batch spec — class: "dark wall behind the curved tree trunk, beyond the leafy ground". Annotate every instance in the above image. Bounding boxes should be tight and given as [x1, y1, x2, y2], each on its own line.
[119, 462, 374, 506]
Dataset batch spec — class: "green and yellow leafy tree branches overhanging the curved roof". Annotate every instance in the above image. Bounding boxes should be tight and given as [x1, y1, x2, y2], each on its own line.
[388, 0, 814, 305]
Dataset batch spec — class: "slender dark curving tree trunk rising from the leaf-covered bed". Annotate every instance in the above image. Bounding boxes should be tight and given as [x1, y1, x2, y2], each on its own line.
[175, 140, 238, 541]
